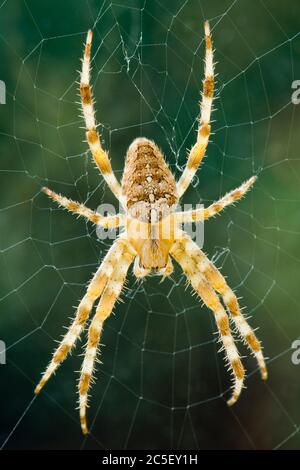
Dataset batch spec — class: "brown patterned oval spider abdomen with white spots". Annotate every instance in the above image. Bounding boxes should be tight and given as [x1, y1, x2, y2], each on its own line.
[122, 138, 178, 222]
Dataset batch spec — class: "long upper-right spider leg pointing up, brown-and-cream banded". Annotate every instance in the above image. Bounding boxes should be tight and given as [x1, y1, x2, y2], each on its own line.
[177, 21, 214, 198]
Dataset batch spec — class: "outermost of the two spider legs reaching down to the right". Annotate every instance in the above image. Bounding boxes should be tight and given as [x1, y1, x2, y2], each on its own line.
[176, 234, 268, 380]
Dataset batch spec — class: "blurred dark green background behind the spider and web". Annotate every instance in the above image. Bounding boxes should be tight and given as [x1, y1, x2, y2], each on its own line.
[0, 0, 300, 450]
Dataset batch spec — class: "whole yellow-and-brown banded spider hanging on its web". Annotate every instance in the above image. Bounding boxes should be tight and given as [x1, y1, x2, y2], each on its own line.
[35, 21, 267, 434]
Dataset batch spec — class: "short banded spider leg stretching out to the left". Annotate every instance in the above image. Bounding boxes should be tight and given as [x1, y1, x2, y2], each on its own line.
[42, 187, 125, 229]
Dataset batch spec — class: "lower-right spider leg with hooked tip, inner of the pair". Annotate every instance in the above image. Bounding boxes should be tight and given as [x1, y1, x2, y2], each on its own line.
[170, 239, 245, 405]
